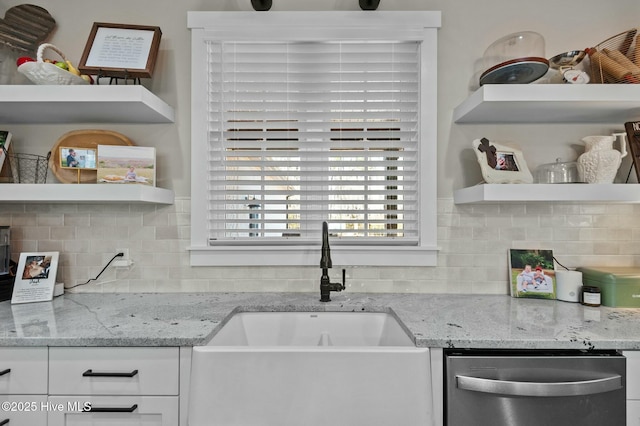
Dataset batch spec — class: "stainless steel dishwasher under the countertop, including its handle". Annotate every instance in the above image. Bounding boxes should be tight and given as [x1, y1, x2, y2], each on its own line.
[445, 349, 626, 426]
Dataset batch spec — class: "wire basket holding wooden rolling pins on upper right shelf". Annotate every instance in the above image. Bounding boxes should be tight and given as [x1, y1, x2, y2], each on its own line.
[587, 28, 640, 84]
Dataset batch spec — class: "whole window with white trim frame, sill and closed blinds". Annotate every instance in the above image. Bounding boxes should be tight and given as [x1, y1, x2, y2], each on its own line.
[188, 11, 440, 266]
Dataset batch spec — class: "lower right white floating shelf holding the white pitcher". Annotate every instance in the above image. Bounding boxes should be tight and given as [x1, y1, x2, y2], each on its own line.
[453, 183, 640, 204]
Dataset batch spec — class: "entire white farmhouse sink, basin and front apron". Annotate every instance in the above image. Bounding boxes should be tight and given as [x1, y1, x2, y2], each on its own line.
[188, 312, 433, 426]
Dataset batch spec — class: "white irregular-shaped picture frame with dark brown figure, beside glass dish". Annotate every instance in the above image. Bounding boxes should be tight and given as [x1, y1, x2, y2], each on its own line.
[473, 138, 533, 183]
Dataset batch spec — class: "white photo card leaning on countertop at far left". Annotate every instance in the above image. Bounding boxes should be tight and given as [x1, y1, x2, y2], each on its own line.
[11, 251, 59, 304]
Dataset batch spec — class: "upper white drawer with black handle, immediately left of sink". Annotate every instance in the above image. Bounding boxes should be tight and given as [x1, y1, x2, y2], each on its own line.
[49, 347, 179, 395]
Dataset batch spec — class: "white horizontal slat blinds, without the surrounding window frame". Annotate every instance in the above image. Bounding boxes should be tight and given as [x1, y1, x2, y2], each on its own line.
[209, 42, 420, 244]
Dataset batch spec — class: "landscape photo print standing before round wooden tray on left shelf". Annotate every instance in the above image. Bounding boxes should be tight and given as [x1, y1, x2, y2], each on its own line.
[98, 145, 156, 186]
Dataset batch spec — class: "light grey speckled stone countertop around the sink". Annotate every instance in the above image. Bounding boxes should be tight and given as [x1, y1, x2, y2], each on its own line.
[0, 292, 640, 349]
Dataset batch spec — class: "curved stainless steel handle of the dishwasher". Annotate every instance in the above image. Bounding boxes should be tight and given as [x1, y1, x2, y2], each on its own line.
[456, 374, 622, 397]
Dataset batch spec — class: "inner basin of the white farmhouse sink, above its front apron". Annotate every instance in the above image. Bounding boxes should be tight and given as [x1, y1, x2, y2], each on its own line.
[208, 312, 414, 347]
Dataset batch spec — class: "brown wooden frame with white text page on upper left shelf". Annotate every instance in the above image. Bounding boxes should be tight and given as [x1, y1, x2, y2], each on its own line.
[78, 22, 162, 78]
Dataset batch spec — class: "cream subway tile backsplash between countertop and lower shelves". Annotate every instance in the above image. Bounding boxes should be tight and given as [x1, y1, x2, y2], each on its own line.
[0, 198, 640, 294]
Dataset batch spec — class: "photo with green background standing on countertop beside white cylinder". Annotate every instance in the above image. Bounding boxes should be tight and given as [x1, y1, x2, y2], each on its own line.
[509, 249, 556, 299]
